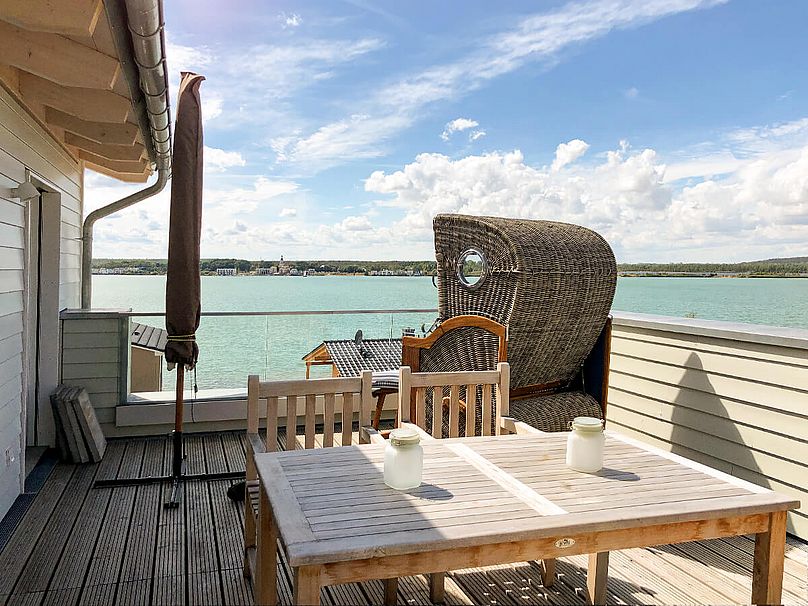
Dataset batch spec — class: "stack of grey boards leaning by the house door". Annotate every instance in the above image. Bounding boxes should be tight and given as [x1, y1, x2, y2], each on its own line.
[51, 385, 107, 463]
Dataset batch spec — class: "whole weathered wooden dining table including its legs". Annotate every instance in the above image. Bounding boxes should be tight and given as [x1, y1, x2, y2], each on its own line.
[255, 432, 799, 604]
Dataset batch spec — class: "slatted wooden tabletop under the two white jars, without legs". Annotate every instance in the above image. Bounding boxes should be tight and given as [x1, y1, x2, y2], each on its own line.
[257, 434, 795, 565]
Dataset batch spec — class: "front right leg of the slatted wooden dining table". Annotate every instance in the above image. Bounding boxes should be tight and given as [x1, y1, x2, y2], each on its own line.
[752, 511, 787, 604]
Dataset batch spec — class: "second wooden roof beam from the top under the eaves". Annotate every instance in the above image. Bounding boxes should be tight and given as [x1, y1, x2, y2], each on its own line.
[0, 20, 121, 90]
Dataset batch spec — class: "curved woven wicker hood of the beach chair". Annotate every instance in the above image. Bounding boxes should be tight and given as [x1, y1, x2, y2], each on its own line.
[433, 215, 617, 388]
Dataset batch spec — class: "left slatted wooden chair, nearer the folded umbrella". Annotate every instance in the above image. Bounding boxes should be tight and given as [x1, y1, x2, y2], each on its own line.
[244, 370, 373, 596]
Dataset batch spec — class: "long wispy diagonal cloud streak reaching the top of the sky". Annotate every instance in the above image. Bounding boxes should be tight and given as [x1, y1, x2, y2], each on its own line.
[280, 0, 728, 170]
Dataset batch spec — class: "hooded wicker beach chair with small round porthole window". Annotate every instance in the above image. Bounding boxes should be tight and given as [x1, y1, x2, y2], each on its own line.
[426, 215, 617, 431]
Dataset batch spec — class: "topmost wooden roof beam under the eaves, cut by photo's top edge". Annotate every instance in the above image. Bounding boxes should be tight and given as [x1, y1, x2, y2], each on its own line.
[3, 0, 104, 36]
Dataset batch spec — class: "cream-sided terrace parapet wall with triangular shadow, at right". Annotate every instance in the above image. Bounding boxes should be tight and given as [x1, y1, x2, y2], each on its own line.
[607, 314, 808, 538]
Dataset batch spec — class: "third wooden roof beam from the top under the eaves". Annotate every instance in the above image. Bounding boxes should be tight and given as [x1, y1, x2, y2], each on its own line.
[20, 72, 132, 123]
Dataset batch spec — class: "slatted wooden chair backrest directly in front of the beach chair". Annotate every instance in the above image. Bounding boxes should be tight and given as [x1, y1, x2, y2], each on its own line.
[398, 362, 510, 438]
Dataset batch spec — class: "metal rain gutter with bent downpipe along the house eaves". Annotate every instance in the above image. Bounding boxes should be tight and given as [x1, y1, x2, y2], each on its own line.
[81, 0, 171, 309]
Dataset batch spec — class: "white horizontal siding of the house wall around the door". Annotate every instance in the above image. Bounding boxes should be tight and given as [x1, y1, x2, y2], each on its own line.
[0, 82, 83, 516]
